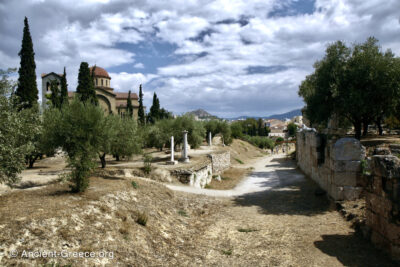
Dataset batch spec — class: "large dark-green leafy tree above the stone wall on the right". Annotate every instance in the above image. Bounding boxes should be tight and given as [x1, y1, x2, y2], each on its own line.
[299, 37, 400, 139]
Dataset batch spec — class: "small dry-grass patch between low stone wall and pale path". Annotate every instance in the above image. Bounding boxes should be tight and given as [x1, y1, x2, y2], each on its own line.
[209, 168, 251, 190]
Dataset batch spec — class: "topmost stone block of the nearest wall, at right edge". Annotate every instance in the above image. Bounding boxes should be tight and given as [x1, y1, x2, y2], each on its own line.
[371, 155, 400, 178]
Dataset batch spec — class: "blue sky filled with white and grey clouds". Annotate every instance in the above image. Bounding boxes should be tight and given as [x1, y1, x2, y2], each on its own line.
[0, 0, 400, 117]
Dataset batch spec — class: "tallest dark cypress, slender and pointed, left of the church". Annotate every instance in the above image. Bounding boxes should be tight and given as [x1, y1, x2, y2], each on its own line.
[15, 17, 38, 108]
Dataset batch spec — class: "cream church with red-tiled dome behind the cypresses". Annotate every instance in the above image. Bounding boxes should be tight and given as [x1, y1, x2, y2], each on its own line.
[42, 66, 139, 119]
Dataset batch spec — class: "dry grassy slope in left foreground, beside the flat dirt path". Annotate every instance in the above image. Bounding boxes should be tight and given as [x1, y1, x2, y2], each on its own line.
[0, 177, 221, 266]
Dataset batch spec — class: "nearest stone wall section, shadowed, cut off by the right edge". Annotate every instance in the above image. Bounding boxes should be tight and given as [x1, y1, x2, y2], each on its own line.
[365, 156, 400, 260]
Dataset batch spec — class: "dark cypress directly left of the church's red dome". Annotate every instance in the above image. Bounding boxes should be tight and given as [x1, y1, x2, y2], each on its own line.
[76, 62, 98, 105]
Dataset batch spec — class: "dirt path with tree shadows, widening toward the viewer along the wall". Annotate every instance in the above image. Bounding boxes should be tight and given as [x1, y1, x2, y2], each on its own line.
[169, 156, 395, 266]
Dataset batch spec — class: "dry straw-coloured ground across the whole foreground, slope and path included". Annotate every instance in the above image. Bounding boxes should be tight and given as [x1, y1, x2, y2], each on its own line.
[0, 154, 398, 266]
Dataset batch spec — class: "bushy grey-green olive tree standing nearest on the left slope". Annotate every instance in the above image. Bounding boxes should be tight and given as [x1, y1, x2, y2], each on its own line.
[44, 99, 105, 192]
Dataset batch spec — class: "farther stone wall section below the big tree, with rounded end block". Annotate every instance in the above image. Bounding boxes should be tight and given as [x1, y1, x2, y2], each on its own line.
[296, 130, 365, 200]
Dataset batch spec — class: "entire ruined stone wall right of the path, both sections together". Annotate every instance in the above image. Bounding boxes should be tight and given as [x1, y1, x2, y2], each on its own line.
[296, 131, 400, 260]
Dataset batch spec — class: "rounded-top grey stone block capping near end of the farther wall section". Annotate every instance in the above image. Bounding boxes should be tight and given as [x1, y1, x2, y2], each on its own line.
[332, 137, 365, 160]
